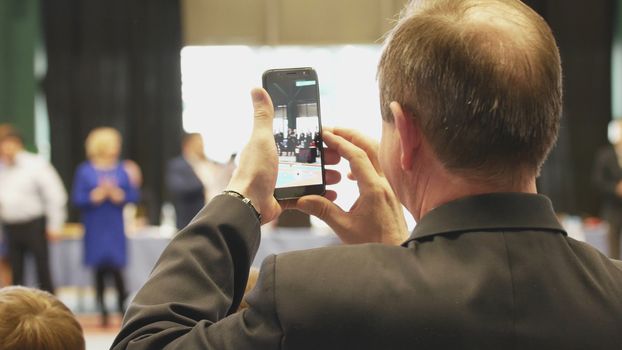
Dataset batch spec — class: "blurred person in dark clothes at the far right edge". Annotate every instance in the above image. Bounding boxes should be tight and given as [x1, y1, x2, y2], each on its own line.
[592, 120, 622, 259]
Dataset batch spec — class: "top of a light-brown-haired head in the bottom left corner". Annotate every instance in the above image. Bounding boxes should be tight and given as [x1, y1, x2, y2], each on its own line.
[0, 287, 85, 350]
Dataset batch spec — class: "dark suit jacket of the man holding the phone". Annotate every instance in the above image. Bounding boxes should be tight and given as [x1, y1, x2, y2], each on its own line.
[114, 194, 622, 350]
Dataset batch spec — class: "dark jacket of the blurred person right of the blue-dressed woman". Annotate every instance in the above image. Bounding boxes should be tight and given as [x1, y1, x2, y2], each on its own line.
[166, 156, 205, 229]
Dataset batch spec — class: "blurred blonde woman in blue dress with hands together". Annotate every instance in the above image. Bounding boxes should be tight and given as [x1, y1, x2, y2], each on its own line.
[71, 127, 139, 326]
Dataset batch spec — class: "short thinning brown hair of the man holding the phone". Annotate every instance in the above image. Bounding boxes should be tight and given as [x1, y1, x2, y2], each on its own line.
[378, 0, 562, 183]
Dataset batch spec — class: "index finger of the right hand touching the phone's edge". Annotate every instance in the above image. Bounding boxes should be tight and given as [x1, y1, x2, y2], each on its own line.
[324, 132, 378, 189]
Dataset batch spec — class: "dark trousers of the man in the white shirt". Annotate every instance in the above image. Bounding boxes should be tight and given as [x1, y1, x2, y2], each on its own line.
[4, 218, 54, 293]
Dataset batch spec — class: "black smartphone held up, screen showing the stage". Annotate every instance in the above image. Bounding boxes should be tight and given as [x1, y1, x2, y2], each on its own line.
[262, 68, 326, 199]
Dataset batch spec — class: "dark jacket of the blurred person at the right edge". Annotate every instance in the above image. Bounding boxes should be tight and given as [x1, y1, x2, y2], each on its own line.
[592, 146, 622, 217]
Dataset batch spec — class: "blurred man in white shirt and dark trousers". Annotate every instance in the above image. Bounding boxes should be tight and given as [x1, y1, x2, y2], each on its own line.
[0, 130, 67, 293]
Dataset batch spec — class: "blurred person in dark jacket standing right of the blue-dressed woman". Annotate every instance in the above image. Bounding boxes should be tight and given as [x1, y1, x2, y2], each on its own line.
[166, 133, 235, 229]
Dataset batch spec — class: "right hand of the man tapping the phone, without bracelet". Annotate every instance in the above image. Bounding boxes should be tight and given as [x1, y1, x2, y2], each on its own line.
[295, 128, 408, 245]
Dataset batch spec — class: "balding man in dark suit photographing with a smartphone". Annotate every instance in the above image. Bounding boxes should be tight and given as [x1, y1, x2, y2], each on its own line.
[114, 0, 622, 350]
